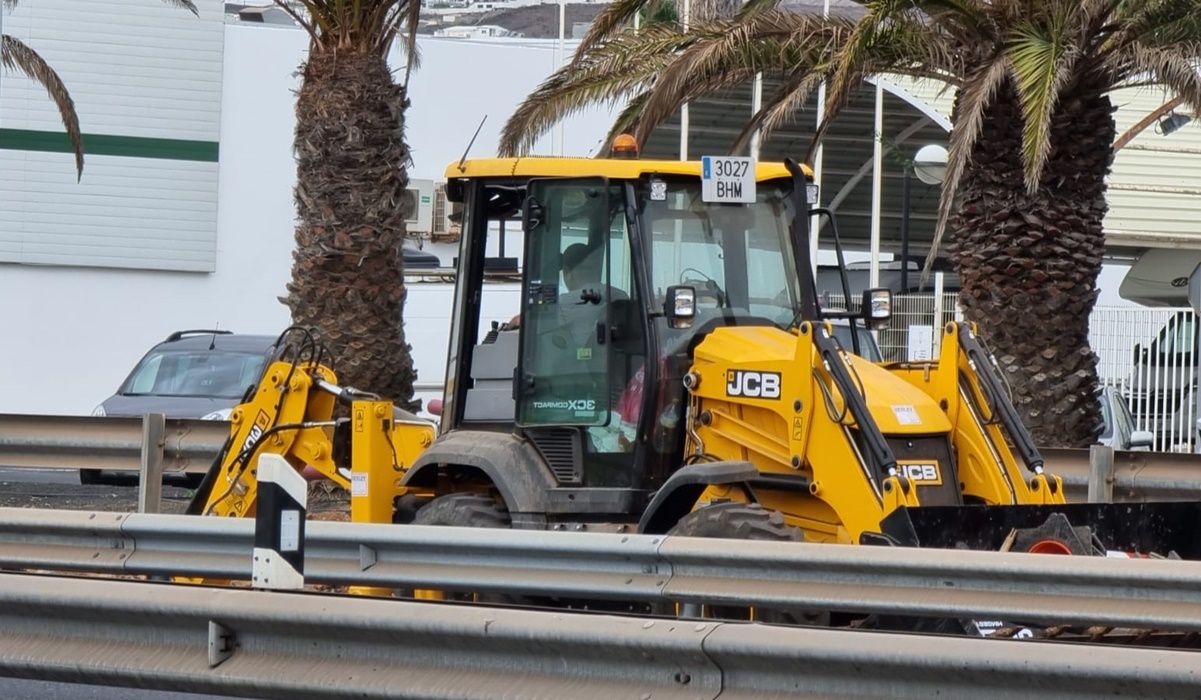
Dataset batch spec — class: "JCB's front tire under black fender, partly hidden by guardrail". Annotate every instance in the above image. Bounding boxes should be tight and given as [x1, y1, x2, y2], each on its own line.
[668, 503, 830, 627]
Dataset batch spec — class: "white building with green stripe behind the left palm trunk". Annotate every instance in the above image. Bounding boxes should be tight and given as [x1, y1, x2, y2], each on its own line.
[0, 0, 610, 414]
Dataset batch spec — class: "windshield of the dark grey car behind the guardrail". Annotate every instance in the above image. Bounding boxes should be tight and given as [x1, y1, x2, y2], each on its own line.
[120, 351, 267, 399]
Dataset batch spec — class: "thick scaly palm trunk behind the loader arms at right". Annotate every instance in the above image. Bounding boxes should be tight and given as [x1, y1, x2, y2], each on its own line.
[951, 78, 1115, 447]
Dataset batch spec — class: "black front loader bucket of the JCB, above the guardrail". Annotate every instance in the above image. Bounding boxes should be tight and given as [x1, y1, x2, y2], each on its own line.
[880, 502, 1201, 561]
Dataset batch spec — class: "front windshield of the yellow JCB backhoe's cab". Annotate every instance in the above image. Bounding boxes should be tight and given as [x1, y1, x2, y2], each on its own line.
[643, 179, 797, 336]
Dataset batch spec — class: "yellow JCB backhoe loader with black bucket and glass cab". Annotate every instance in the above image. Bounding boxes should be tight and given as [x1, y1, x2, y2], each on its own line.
[184, 144, 1201, 576]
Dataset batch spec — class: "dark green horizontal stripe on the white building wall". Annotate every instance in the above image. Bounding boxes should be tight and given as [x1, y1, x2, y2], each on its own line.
[0, 128, 219, 163]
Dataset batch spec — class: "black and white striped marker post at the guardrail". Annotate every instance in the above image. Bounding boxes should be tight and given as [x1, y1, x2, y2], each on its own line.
[251, 454, 309, 590]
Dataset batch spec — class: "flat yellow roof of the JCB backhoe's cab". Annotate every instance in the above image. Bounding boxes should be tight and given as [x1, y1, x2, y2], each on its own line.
[446, 157, 813, 183]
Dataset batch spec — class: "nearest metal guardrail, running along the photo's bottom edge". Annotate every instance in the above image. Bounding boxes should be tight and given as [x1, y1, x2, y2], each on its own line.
[0, 574, 1197, 700]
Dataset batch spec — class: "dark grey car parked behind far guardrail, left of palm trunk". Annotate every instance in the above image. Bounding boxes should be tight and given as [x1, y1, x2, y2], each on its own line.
[87, 330, 277, 484]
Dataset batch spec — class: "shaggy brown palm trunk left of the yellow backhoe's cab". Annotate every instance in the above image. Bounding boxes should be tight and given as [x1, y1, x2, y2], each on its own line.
[285, 46, 416, 406]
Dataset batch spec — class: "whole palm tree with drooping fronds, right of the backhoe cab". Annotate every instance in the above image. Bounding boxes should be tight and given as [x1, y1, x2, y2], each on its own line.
[502, 0, 1201, 445]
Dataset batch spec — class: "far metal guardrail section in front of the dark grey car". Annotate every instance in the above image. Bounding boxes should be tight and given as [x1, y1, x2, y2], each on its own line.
[0, 413, 229, 473]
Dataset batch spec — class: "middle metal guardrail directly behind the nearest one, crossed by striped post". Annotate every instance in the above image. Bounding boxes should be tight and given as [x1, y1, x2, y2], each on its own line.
[7, 508, 1201, 632]
